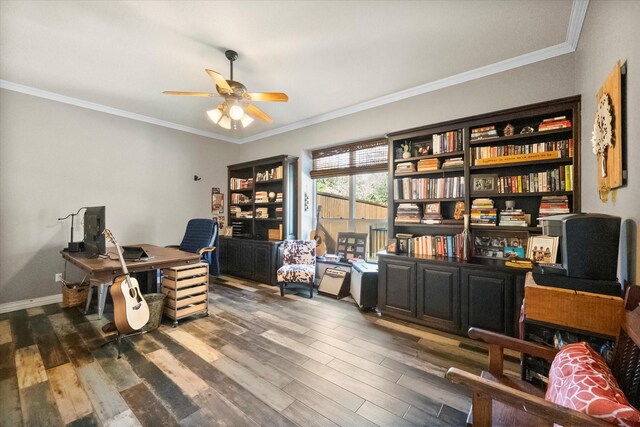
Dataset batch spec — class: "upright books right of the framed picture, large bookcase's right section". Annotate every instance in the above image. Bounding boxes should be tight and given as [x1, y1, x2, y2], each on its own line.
[497, 165, 573, 193]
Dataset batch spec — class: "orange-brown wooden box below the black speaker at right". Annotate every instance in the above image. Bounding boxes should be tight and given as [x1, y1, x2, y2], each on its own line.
[524, 273, 624, 337]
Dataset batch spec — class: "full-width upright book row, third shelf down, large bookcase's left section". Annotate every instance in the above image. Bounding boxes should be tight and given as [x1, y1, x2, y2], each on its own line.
[393, 176, 464, 200]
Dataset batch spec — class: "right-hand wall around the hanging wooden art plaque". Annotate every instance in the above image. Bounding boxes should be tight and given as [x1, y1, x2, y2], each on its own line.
[574, 1, 640, 284]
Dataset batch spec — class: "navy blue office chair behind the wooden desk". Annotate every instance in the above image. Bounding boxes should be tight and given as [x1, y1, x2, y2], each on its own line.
[167, 218, 220, 276]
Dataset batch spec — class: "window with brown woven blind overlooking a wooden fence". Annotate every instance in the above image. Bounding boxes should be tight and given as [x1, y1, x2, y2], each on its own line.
[311, 140, 388, 259]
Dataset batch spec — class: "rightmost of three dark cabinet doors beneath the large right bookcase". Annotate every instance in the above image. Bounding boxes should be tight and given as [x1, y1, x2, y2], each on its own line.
[461, 268, 514, 336]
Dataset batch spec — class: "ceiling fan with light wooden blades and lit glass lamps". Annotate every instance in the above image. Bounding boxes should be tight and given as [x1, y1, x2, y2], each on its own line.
[162, 50, 289, 129]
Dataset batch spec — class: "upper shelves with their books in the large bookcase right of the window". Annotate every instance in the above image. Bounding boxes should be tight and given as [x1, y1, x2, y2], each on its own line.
[387, 96, 580, 258]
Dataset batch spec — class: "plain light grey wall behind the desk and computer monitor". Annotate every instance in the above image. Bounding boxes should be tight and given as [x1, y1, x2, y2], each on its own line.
[0, 90, 238, 303]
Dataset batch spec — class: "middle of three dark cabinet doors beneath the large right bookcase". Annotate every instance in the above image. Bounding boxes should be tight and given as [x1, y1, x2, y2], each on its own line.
[417, 263, 460, 332]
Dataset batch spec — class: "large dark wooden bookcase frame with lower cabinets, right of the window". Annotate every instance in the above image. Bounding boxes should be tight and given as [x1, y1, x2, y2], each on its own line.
[378, 96, 580, 336]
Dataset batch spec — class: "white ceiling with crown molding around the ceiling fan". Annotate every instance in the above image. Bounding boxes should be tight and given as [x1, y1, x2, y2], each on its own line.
[0, 0, 587, 143]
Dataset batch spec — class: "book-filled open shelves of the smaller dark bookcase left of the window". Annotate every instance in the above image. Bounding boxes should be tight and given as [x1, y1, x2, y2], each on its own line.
[227, 155, 298, 240]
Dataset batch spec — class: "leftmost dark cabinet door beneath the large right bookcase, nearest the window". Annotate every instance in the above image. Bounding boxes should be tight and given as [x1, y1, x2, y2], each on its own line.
[378, 258, 416, 317]
